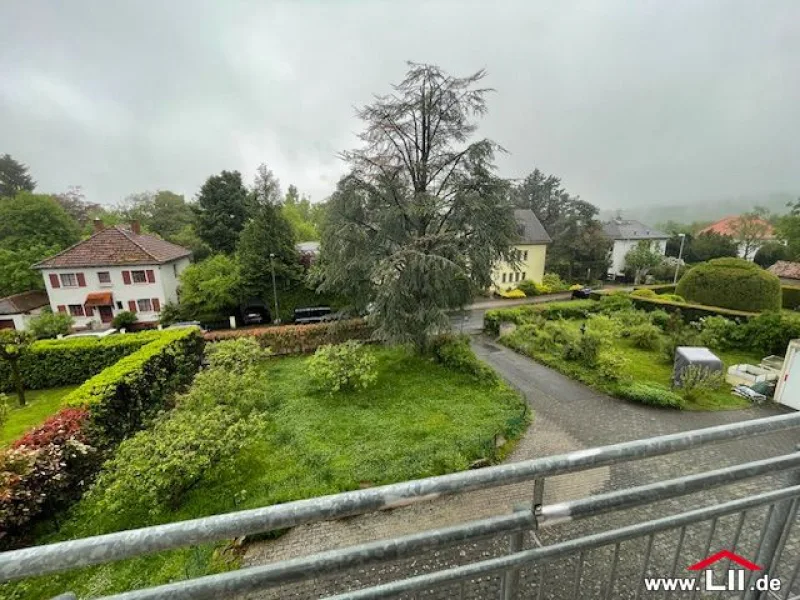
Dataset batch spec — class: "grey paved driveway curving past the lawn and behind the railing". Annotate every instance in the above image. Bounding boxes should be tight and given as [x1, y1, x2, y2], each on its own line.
[245, 336, 800, 600]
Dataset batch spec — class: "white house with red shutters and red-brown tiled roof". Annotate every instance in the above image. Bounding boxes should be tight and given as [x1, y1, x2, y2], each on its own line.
[33, 220, 192, 329]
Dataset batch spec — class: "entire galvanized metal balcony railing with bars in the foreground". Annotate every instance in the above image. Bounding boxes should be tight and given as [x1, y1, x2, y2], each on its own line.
[0, 413, 800, 600]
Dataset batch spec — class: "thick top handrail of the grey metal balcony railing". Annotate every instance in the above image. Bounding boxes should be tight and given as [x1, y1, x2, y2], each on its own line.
[0, 413, 800, 581]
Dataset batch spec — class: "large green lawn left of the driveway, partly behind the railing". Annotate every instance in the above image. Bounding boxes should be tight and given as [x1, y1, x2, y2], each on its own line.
[9, 348, 529, 598]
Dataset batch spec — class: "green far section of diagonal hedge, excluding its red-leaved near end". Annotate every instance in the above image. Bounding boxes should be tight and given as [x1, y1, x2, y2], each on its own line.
[64, 328, 203, 446]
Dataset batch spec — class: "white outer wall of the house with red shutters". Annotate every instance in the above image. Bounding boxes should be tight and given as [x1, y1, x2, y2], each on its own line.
[42, 258, 191, 329]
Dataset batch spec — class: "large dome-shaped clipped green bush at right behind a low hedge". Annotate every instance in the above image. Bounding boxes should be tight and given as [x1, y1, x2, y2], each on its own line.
[676, 258, 781, 312]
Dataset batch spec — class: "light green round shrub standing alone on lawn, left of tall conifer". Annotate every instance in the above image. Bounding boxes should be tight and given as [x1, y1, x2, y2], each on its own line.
[308, 340, 377, 394]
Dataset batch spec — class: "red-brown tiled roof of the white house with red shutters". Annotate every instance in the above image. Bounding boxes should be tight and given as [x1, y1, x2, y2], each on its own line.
[33, 225, 191, 269]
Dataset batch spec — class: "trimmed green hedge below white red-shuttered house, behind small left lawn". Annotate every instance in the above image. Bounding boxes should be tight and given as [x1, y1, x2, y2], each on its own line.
[0, 331, 165, 392]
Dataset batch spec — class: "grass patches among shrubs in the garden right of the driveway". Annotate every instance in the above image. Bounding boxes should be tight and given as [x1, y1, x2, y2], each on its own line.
[502, 319, 762, 410]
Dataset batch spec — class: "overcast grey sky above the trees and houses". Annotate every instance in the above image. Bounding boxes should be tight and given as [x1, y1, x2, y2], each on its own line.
[0, 0, 800, 208]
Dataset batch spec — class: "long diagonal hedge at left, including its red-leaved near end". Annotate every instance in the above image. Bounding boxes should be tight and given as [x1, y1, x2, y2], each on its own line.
[0, 328, 203, 549]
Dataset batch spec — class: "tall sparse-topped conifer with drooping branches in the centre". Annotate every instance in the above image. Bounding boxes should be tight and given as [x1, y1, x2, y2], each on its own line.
[321, 63, 517, 349]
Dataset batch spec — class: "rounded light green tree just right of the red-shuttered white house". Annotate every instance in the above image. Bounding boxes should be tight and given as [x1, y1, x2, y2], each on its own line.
[180, 254, 241, 321]
